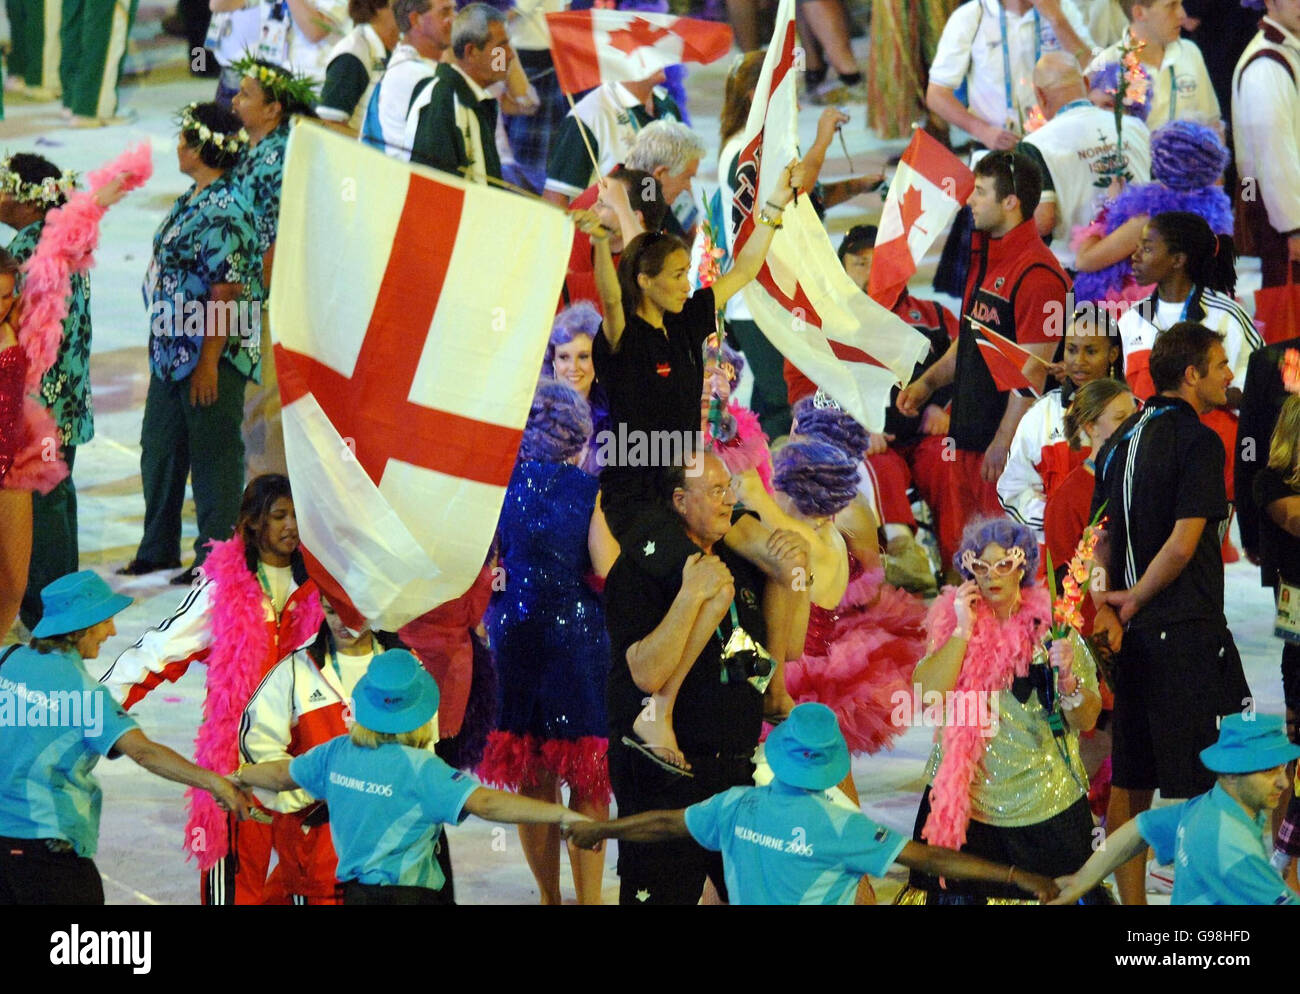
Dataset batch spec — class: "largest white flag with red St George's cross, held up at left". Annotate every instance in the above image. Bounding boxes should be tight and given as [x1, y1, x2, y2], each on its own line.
[270, 123, 573, 631]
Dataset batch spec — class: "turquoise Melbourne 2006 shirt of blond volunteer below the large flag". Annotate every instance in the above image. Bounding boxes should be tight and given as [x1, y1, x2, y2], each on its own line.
[289, 735, 480, 890]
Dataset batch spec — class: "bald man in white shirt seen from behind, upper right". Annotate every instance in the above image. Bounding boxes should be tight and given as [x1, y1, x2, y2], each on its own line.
[1022, 52, 1151, 275]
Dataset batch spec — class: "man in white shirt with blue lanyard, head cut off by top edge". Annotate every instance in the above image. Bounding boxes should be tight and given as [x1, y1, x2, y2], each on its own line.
[926, 0, 1092, 151]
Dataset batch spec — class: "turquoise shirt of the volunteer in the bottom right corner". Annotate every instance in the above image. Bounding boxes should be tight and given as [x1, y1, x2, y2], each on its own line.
[1138, 784, 1296, 904]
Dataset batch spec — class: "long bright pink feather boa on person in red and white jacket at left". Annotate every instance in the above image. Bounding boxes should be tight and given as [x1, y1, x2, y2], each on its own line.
[185, 535, 324, 871]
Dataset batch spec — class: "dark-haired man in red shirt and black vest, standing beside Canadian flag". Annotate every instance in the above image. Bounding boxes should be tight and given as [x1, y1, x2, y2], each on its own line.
[896, 152, 1070, 576]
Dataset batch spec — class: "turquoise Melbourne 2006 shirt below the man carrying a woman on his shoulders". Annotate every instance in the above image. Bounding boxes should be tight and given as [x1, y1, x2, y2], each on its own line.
[686, 781, 907, 904]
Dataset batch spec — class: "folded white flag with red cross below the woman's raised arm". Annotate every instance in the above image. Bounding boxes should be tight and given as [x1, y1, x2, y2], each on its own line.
[724, 0, 930, 431]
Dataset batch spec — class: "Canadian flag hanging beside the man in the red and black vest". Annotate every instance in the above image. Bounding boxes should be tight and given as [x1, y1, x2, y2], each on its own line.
[867, 127, 975, 308]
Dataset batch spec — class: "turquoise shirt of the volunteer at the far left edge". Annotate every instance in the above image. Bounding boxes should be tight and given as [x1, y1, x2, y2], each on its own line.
[0, 646, 137, 859]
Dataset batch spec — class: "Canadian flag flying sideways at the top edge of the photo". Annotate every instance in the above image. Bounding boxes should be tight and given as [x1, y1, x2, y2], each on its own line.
[546, 10, 732, 94]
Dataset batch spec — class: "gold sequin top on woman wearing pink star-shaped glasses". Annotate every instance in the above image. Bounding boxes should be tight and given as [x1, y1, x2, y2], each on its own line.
[926, 634, 1097, 828]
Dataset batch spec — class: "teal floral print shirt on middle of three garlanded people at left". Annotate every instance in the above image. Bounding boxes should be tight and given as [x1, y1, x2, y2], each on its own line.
[142, 173, 265, 382]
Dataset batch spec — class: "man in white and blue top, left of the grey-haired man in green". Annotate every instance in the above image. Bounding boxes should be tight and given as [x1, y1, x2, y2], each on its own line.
[361, 0, 456, 160]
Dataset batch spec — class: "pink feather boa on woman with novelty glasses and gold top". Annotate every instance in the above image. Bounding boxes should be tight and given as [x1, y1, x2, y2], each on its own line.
[922, 586, 1052, 848]
